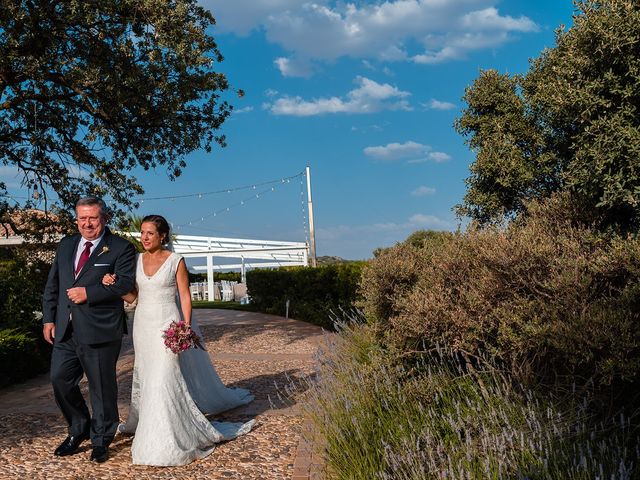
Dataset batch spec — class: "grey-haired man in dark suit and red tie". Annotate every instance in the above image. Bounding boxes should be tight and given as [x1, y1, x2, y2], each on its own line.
[43, 197, 135, 462]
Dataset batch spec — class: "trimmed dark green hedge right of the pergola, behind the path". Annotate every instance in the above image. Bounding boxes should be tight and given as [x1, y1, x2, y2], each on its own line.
[247, 262, 365, 329]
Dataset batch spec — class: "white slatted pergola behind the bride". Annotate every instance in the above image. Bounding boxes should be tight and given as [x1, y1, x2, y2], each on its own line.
[129, 233, 309, 298]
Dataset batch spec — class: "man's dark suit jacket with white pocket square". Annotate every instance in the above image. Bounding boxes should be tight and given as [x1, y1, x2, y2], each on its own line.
[42, 227, 136, 344]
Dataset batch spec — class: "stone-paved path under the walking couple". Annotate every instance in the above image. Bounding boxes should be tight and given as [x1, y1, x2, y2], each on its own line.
[0, 310, 322, 480]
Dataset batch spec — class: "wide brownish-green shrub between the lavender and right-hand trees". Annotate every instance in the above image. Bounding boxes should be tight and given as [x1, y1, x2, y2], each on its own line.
[362, 193, 640, 395]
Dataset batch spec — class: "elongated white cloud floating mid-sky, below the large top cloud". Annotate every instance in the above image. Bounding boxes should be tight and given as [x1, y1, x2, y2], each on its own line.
[267, 77, 411, 117]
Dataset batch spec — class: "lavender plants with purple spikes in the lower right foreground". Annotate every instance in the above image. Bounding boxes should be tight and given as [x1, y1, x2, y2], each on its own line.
[303, 325, 640, 480]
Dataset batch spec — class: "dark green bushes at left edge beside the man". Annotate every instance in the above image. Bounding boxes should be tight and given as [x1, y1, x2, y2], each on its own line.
[0, 249, 51, 387]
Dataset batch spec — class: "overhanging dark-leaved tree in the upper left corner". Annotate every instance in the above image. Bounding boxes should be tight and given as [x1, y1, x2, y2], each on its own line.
[0, 0, 242, 236]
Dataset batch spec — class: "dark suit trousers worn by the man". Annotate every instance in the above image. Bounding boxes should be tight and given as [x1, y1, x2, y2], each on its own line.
[51, 323, 122, 447]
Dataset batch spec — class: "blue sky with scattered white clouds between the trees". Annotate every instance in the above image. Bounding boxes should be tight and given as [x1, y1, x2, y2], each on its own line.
[3, 0, 573, 259]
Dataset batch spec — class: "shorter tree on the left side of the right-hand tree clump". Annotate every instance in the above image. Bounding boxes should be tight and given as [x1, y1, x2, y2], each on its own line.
[456, 70, 560, 224]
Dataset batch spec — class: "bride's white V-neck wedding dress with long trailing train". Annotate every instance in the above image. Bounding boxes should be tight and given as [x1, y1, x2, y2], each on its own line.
[119, 253, 255, 466]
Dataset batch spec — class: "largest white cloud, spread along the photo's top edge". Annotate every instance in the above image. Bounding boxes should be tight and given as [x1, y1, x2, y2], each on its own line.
[201, 0, 538, 68]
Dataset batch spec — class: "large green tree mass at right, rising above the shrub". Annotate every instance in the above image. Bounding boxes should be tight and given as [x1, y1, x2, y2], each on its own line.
[456, 0, 640, 229]
